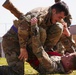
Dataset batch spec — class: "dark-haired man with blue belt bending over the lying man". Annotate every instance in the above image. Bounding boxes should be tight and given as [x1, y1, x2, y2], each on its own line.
[0, 0, 75, 75]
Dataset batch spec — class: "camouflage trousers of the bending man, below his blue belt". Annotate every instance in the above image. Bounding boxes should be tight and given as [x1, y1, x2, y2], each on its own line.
[2, 29, 24, 75]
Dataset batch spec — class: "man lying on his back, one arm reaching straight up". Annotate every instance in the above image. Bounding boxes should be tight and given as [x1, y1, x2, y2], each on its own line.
[31, 20, 76, 74]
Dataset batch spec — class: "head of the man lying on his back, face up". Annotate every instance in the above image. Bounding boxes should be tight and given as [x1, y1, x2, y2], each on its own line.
[61, 52, 76, 71]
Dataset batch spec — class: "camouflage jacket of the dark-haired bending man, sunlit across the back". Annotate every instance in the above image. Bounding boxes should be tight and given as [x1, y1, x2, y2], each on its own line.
[18, 7, 52, 47]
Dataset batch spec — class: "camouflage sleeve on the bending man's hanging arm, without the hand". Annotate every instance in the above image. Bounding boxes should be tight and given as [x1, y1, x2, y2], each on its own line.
[18, 20, 29, 48]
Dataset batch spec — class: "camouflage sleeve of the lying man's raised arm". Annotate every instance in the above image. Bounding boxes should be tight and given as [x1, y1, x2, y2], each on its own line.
[31, 25, 53, 72]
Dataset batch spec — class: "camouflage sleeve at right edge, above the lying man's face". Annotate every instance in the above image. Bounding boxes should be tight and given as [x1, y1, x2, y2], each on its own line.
[60, 35, 76, 52]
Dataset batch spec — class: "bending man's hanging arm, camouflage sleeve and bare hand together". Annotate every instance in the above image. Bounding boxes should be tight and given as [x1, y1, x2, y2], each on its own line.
[18, 20, 29, 60]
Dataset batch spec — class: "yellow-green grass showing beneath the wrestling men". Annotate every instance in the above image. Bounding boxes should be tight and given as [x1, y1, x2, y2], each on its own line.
[0, 58, 76, 75]
